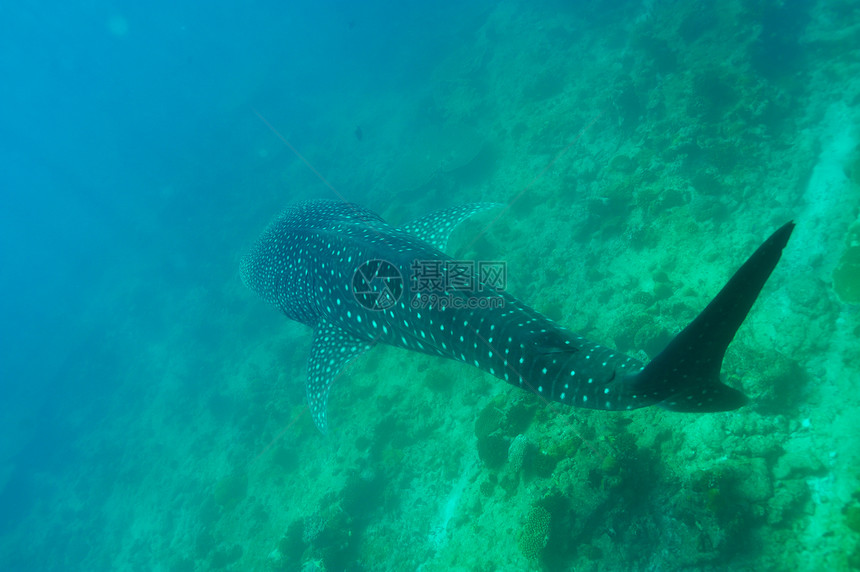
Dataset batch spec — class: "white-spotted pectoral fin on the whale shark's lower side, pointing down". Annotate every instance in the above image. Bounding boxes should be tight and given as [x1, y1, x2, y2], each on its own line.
[307, 319, 373, 434]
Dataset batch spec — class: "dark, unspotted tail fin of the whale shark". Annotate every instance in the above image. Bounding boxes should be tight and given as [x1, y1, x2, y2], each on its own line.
[624, 222, 794, 412]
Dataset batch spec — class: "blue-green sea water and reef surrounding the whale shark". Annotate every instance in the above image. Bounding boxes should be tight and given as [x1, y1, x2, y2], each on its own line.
[0, 0, 860, 572]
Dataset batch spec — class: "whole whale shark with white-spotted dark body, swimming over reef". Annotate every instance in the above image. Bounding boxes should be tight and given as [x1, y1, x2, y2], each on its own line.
[241, 200, 794, 433]
